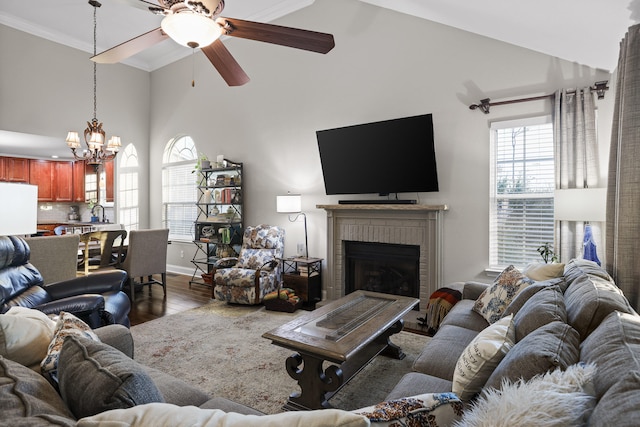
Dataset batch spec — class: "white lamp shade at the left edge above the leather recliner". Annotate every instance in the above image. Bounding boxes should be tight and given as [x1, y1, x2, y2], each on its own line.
[0, 182, 38, 236]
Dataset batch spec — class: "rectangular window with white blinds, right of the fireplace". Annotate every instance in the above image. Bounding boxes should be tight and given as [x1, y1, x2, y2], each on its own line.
[489, 117, 555, 268]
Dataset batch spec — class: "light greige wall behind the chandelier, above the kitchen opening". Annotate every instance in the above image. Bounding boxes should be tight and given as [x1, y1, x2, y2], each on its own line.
[0, 25, 151, 231]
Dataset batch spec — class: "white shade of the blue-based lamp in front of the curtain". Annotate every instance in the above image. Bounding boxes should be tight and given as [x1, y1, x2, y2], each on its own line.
[553, 188, 607, 222]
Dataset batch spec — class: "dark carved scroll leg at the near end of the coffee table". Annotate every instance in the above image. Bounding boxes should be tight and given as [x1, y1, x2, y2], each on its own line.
[284, 353, 344, 410]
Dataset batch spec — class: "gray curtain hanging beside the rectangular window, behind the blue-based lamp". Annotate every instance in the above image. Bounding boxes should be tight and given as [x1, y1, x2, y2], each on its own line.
[553, 88, 603, 262]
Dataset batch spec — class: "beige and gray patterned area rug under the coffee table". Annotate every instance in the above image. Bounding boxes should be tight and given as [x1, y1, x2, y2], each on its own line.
[131, 301, 429, 414]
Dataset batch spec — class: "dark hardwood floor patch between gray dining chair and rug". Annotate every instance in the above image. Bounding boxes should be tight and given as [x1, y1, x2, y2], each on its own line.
[129, 273, 211, 326]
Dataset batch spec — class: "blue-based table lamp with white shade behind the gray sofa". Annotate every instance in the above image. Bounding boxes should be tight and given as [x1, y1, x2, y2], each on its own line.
[553, 188, 607, 265]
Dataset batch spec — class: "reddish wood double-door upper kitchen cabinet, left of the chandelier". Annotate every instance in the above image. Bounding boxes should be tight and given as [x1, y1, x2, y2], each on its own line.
[29, 159, 73, 202]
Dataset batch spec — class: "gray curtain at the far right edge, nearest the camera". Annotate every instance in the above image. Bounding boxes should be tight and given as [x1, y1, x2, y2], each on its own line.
[606, 24, 640, 310]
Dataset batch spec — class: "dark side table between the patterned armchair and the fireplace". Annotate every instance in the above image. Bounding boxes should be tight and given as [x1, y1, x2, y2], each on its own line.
[282, 257, 323, 310]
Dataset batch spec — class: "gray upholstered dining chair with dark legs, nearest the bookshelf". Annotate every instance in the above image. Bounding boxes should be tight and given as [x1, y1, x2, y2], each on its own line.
[120, 228, 169, 302]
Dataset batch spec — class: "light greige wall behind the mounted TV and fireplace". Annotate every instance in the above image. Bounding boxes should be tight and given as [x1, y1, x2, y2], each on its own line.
[150, 0, 613, 283]
